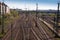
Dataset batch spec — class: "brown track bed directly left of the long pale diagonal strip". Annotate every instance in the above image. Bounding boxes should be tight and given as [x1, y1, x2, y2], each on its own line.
[39, 20, 55, 40]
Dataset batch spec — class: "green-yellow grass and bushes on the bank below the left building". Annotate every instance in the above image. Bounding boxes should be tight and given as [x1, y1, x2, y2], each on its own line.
[0, 11, 19, 38]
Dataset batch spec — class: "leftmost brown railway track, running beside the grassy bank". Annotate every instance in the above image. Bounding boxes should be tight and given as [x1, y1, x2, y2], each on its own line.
[2, 13, 25, 40]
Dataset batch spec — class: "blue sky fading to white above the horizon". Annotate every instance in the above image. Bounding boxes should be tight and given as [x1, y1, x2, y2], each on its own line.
[0, 0, 59, 10]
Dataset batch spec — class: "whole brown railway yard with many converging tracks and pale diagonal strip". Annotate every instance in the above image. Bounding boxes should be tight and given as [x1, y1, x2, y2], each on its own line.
[0, 13, 60, 40]
